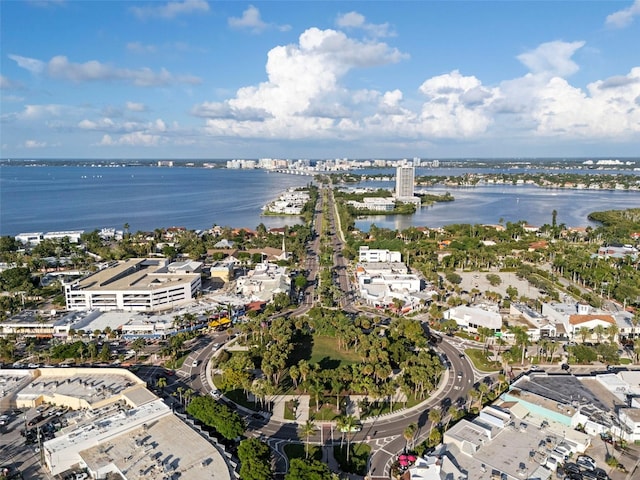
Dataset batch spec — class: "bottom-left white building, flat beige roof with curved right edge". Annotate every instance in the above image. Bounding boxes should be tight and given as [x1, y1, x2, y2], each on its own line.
[43, 400, 231, 480]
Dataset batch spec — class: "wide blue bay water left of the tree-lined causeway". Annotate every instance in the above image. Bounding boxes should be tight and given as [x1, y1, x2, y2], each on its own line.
[0, 166, 312, 235]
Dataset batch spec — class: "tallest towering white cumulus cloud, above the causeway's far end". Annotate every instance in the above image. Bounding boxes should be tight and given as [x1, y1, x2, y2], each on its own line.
[198, 28, 406, 131]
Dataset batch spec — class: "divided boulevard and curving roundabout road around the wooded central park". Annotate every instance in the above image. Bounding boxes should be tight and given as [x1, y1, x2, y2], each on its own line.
[152, 190, 483, 480]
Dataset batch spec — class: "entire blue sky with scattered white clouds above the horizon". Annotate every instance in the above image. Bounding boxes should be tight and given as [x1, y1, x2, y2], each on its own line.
[0, 0, 640, 158]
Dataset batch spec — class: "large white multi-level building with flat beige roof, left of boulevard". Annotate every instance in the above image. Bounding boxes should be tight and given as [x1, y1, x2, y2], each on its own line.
[64, 258, 202, 311]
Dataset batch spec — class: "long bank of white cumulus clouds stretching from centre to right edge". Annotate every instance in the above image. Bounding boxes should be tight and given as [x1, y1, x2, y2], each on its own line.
[182, 30, 640, 145]
